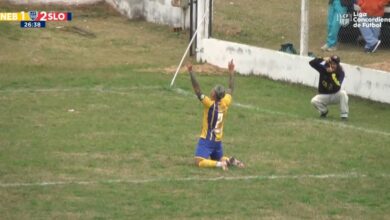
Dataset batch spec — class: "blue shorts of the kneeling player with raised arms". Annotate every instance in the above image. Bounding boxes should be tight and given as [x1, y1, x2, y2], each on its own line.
[195, 138, 223, 161]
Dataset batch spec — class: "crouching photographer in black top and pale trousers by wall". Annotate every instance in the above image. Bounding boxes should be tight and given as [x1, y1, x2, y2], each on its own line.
[309, 55, 349, 120]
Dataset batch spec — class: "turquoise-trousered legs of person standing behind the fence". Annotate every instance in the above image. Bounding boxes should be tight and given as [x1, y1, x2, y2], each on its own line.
[321, 0, 353, 51]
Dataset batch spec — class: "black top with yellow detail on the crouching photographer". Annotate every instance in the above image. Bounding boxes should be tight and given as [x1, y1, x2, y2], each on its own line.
[309, 58, 344, 94]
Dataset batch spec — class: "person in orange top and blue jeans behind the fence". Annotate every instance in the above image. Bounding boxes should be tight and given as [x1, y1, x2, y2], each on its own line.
[358, 0, 390, 53]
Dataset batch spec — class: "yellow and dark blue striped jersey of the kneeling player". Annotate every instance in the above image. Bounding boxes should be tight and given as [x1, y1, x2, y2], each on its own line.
[200, 94, 232, 141]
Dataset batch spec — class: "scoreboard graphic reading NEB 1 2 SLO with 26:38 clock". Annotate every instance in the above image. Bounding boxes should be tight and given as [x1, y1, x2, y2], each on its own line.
[0, 11, 72, 28]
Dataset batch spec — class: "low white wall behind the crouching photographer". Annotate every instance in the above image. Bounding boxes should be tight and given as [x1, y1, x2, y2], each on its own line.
[199, 39, 390, 103]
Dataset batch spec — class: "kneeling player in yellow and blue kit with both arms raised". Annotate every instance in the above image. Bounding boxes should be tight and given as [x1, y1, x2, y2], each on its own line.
[187, 60, 244, 170]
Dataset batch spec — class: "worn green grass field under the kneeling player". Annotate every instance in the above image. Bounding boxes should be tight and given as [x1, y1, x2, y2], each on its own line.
[0, 2, 390, 219]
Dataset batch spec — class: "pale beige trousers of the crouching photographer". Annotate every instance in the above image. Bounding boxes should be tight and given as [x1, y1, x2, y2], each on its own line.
[311, 90, 349, 117]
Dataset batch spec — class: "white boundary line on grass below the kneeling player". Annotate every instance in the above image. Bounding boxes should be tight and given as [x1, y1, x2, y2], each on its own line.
[0, 173, 390, 188]
